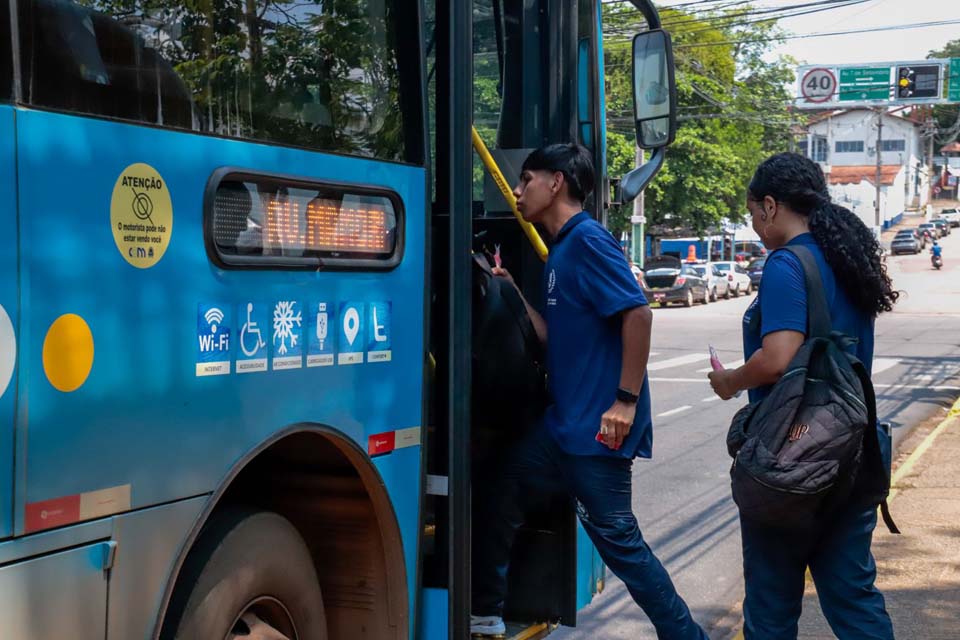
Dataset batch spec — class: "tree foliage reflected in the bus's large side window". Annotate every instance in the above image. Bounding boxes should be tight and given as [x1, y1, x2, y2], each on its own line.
[74, 0, 403, 159]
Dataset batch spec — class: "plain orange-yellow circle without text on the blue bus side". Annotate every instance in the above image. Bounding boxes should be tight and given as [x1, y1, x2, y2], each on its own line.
[43, 313, 93, 393]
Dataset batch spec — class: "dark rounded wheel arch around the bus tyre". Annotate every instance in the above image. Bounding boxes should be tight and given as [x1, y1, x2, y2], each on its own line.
[152, 423, 411, 640]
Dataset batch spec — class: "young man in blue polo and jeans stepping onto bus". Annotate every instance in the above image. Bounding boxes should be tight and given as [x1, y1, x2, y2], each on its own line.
[471, 144, 707, 640]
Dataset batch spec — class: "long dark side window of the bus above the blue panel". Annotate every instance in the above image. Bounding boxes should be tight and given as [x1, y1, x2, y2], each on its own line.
[17, 0, 422, 162]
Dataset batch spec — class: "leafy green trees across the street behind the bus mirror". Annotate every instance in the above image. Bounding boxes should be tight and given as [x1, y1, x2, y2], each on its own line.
[604, 4, 794, 233]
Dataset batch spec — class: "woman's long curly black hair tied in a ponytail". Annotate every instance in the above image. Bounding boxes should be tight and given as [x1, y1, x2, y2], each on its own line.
[749, 153, 900, 317]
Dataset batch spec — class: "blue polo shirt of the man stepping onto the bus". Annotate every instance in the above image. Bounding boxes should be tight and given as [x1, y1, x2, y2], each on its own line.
[544, 212, 653, 459]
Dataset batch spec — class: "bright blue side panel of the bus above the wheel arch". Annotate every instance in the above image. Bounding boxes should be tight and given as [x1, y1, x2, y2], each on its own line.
[14, 111, 425, 632]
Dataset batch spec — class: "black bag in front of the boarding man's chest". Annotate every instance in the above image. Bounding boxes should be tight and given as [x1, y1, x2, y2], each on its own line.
[473, 253, 547, 436]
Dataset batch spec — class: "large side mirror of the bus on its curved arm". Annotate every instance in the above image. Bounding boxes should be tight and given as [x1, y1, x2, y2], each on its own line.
[620, 29, 677, 204]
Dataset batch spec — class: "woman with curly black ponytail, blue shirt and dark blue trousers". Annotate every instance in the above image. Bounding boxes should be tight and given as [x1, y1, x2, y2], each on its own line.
[710, 153, 898, 640]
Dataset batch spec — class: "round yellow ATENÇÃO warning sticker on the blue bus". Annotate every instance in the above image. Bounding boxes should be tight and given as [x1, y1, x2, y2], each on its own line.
[110, 162, 173, 269]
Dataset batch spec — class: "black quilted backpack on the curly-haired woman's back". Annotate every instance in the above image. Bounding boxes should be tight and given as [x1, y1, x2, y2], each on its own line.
[727, 246, 899, 533]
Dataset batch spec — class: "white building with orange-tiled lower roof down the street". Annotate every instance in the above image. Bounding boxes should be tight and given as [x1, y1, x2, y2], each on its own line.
[800, 109, 929, 227]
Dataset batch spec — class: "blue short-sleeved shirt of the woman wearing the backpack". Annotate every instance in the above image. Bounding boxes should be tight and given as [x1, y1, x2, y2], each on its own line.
[743, 233, 873, 402]
